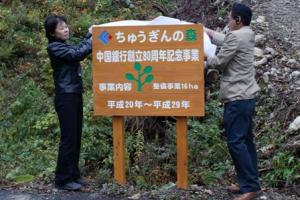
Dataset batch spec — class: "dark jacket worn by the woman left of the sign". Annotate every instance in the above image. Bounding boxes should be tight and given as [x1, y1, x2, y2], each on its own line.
[47, 34, 92, 93]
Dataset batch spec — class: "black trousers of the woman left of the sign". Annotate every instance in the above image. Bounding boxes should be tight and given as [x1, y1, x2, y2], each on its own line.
[54, 93, 83, 185]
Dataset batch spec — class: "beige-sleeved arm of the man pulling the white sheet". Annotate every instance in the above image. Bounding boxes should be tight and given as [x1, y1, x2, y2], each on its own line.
[207, 33, 239, 71]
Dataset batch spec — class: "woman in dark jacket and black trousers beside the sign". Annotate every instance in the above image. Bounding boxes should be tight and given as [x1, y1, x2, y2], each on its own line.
[44, 15, 92, 190]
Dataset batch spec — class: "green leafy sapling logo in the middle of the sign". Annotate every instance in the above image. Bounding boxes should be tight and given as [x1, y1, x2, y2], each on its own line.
[125, 62, 154, 92]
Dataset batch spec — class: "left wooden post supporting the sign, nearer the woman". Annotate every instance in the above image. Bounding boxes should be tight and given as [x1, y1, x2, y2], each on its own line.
[113, 116, 126, 185]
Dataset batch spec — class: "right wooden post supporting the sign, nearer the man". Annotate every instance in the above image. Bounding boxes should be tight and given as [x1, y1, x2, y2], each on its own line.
[176, 117, 188, 189]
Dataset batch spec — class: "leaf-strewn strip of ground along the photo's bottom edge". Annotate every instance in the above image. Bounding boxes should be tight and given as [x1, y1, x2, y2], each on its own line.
[0, 183, 300, 200]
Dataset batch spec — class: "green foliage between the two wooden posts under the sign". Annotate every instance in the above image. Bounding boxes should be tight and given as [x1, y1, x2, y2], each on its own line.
[126, 127, 176, 188]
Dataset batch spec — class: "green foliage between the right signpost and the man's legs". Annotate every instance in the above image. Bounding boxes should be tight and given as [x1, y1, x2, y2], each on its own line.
[189, 97, 230, 184]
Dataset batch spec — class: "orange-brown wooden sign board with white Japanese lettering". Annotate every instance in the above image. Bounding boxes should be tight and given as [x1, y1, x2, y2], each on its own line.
[92, 24, 204, 116]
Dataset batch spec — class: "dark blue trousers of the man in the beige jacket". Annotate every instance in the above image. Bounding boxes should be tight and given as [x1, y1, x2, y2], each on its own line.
[224, 99, 260, 193]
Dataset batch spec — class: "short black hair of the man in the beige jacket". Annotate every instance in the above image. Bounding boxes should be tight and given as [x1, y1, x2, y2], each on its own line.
[231, 3, 252, 26]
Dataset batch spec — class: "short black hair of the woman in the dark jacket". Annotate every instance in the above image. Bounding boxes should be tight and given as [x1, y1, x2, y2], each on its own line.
[44, 15, 67, 41]
